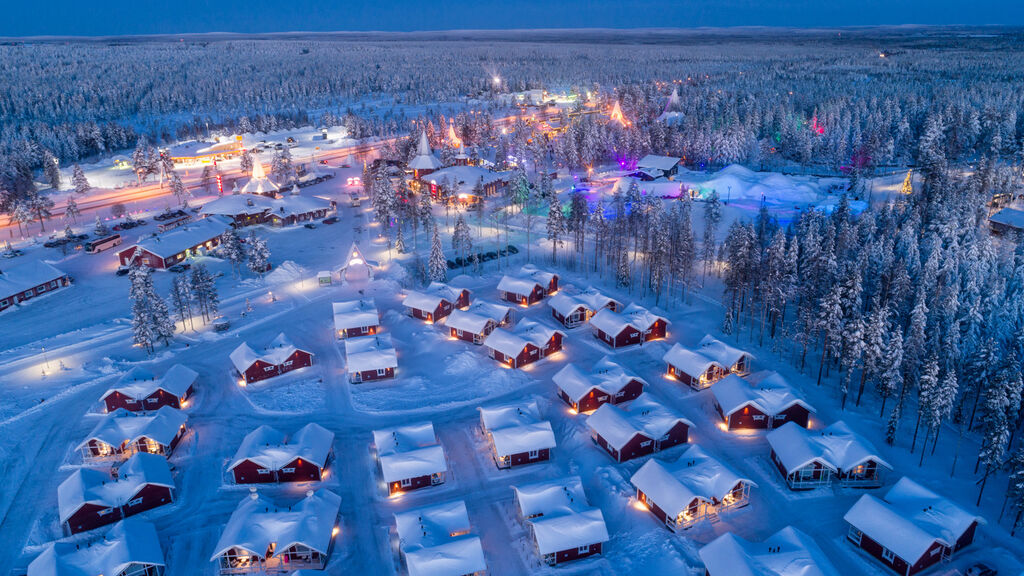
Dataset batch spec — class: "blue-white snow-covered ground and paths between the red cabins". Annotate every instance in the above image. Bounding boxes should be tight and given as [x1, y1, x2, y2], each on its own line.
[0, 162, 1024, 576]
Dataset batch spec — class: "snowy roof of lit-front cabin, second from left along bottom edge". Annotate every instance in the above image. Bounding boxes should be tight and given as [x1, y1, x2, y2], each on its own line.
[210, 489, 341, 561]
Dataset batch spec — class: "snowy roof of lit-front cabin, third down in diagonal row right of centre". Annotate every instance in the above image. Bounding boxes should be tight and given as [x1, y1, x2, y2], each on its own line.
[630, 445, 757, 518]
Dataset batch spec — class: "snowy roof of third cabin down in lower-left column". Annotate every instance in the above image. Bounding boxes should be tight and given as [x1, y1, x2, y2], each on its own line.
[57, 452, 174, 523]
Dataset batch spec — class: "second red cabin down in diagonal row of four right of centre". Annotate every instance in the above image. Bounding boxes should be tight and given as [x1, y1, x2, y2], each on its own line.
[587, 393, 693, 462]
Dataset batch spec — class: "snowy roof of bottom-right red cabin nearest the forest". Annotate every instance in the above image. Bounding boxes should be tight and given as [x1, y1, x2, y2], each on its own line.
[843, 477, 985, 564]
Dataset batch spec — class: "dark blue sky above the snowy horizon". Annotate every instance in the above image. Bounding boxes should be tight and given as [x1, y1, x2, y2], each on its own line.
[0, 0, 1024, 36]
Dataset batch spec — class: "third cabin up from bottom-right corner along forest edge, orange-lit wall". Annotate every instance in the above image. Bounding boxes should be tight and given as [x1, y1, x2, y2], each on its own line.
[711, 370, 814, 430]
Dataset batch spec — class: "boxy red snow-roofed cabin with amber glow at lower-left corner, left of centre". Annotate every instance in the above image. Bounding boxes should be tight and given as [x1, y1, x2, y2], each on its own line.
[374, 422, 447, 495]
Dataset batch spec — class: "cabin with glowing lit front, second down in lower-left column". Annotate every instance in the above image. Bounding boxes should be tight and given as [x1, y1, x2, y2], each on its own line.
[77, 406, 188, 462]
